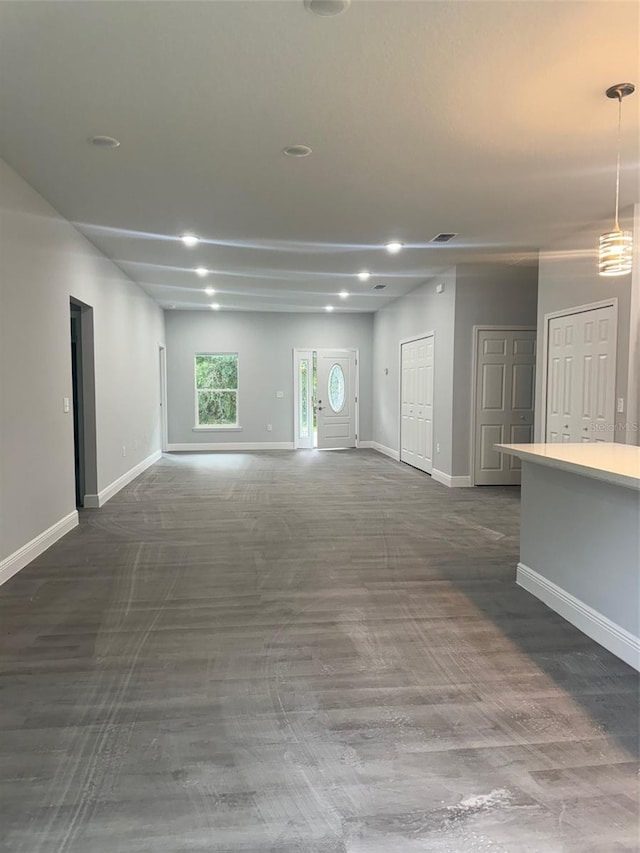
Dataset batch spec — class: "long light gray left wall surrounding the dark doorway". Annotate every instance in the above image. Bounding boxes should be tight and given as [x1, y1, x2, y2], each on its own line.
[0, 160, 164, 563]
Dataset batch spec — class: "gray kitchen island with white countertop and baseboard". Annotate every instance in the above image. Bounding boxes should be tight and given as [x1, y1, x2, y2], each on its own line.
[496, 442, 640, 670]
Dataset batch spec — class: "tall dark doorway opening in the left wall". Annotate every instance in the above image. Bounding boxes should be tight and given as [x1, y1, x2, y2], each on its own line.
[69, 298, 98, 508]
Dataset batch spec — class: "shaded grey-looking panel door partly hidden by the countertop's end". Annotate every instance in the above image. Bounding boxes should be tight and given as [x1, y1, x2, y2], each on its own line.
[474, 329, 536, 486]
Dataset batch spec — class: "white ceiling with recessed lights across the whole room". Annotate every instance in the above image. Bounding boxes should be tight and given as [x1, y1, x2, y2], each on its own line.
[0, 0, 640, 311]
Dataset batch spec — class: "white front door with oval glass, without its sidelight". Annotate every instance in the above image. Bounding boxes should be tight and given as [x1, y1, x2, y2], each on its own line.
[316, 349, 357, 450]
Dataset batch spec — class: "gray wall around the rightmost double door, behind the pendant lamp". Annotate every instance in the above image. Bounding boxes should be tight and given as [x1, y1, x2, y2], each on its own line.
[534, 207, 640, 444]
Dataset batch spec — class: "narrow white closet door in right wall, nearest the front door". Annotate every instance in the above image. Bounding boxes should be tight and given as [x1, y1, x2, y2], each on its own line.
[400, 335, 434, 474]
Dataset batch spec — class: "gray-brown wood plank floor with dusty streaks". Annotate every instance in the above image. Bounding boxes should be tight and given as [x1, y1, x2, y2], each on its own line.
[0, 451, 640, 853]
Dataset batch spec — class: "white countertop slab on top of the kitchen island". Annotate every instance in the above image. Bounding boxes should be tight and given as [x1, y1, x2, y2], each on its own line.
[495, 441, 640, 491]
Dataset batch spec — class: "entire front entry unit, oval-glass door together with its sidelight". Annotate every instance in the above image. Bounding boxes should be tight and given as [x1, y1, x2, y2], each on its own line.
[293, 349, 358, 450]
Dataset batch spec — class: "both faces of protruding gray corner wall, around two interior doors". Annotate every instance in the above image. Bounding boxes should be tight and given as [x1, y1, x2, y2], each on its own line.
[373, 264, 537, 476]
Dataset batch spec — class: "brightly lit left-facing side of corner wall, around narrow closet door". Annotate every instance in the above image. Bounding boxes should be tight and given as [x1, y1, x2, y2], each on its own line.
[373, 268, 456, 474]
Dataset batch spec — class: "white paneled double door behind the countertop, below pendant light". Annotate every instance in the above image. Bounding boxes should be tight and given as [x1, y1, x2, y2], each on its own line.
[545, 305, 617, 443]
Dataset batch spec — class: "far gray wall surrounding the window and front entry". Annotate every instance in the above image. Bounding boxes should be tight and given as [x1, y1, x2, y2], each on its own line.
[165, 311, 373, 444]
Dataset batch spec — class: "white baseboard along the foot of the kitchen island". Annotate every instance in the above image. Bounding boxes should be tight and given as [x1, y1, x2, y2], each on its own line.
[516, 563, 640, 671]
